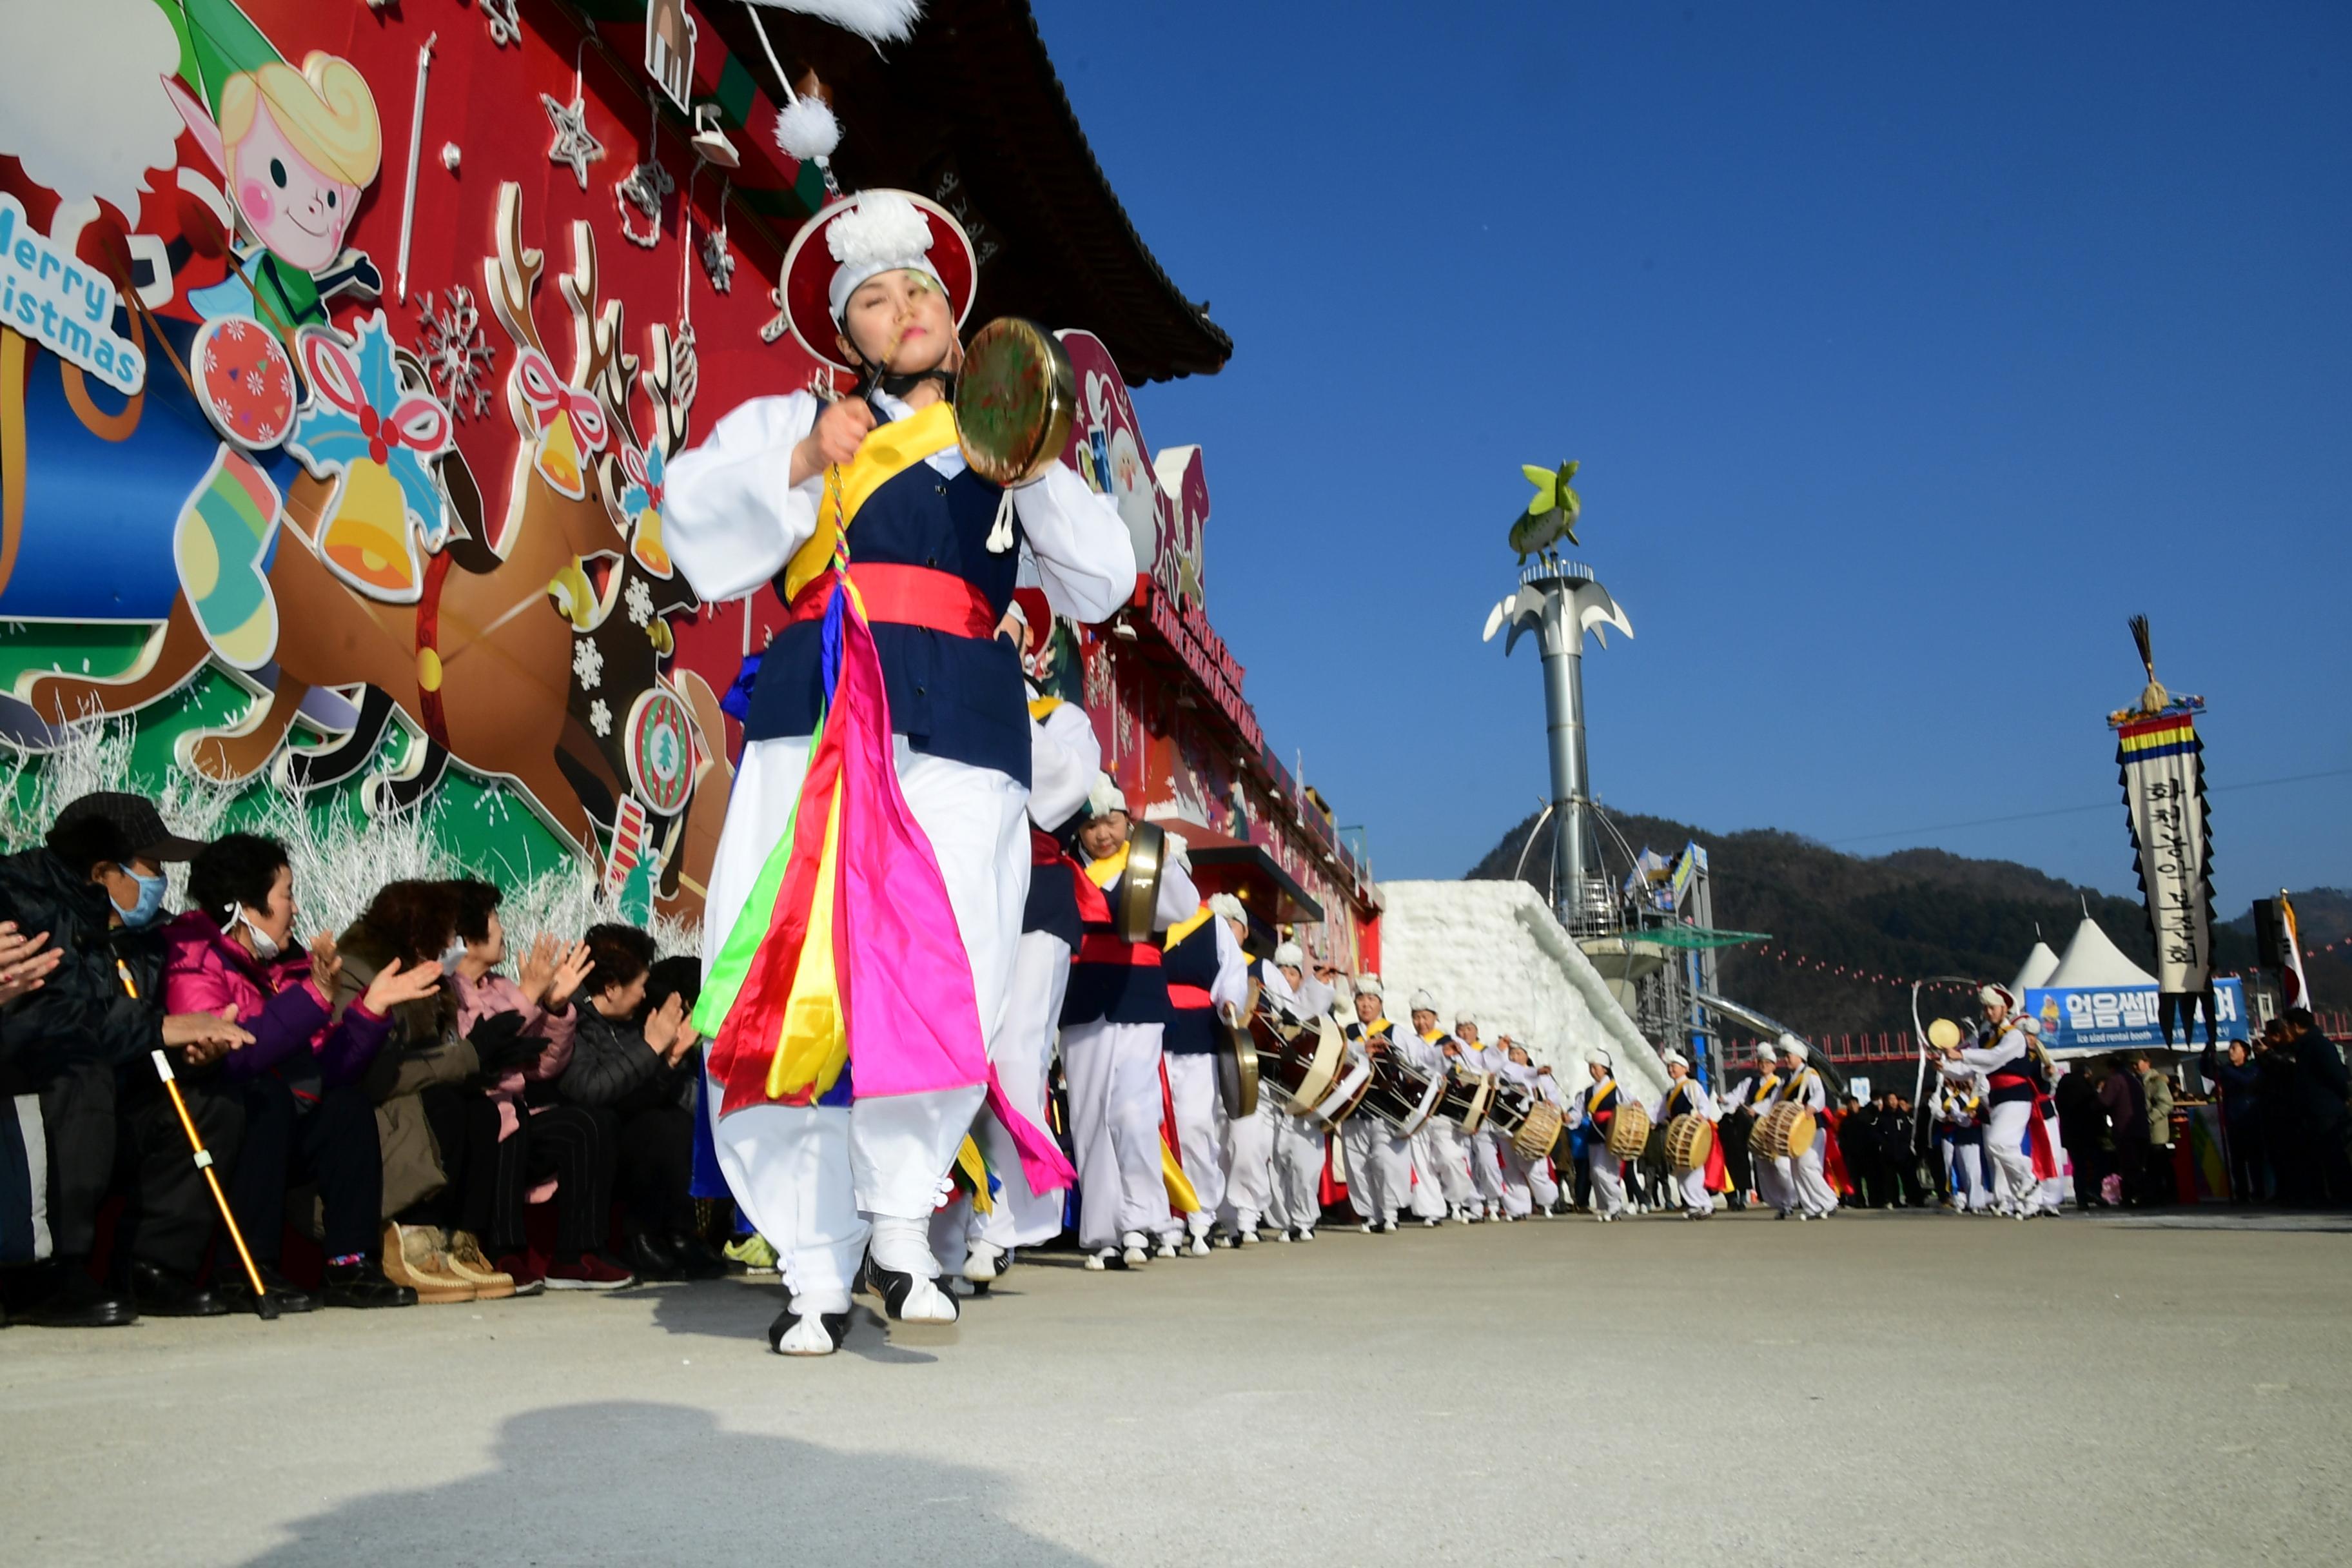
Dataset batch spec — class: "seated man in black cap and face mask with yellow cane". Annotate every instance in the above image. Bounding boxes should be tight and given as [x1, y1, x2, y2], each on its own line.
[0, 790, 251, 1328]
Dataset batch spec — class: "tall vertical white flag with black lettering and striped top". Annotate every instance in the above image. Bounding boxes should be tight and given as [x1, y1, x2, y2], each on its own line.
[2108, 616, 2213, 1041]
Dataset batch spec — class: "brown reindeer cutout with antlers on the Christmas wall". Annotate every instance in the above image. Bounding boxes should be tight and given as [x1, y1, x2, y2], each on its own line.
[17, 183, 727, 903]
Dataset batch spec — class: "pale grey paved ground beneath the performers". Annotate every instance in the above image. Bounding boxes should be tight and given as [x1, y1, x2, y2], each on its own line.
[0, 1215, 2352, 1568]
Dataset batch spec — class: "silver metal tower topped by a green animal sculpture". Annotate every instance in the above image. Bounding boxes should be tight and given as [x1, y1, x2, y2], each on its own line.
[1487, 463, 1632, 934]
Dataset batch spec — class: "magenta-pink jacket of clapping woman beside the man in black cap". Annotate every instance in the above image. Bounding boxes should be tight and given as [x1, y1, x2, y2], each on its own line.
[162, 910, 393, 1100]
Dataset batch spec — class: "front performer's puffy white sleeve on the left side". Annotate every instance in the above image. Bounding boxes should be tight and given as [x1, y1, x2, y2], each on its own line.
[661, 393, 825, 604]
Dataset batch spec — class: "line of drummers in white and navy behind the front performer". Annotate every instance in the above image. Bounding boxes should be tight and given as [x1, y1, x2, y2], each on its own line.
[932, 780, 1837, 1293]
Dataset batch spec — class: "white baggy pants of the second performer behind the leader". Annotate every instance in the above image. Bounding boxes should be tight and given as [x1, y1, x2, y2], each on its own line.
[1061, 1020, 1171, 1253]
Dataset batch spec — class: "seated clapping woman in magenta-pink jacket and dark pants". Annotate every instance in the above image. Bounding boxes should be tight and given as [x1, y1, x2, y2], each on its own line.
[164, 832, 440, 1312]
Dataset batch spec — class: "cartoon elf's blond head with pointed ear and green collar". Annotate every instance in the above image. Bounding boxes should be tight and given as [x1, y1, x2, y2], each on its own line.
[164, 50, 384, 348]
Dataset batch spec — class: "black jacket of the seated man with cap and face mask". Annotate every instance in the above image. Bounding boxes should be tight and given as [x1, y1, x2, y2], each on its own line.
[0, 848, 162, 1084]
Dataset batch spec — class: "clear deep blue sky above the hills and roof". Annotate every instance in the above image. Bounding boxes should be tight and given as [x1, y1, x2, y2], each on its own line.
[1037, 0, 2352, 914]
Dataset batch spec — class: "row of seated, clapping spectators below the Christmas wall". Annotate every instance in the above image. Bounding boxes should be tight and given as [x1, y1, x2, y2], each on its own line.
[0, 792, 729, 1328]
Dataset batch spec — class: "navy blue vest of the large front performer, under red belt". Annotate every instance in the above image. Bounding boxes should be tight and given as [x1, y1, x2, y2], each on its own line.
[743, 463, 1030, 787]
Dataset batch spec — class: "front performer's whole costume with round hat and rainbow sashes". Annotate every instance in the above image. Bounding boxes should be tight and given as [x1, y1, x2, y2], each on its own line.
[665, 190, 1136, 1354]
